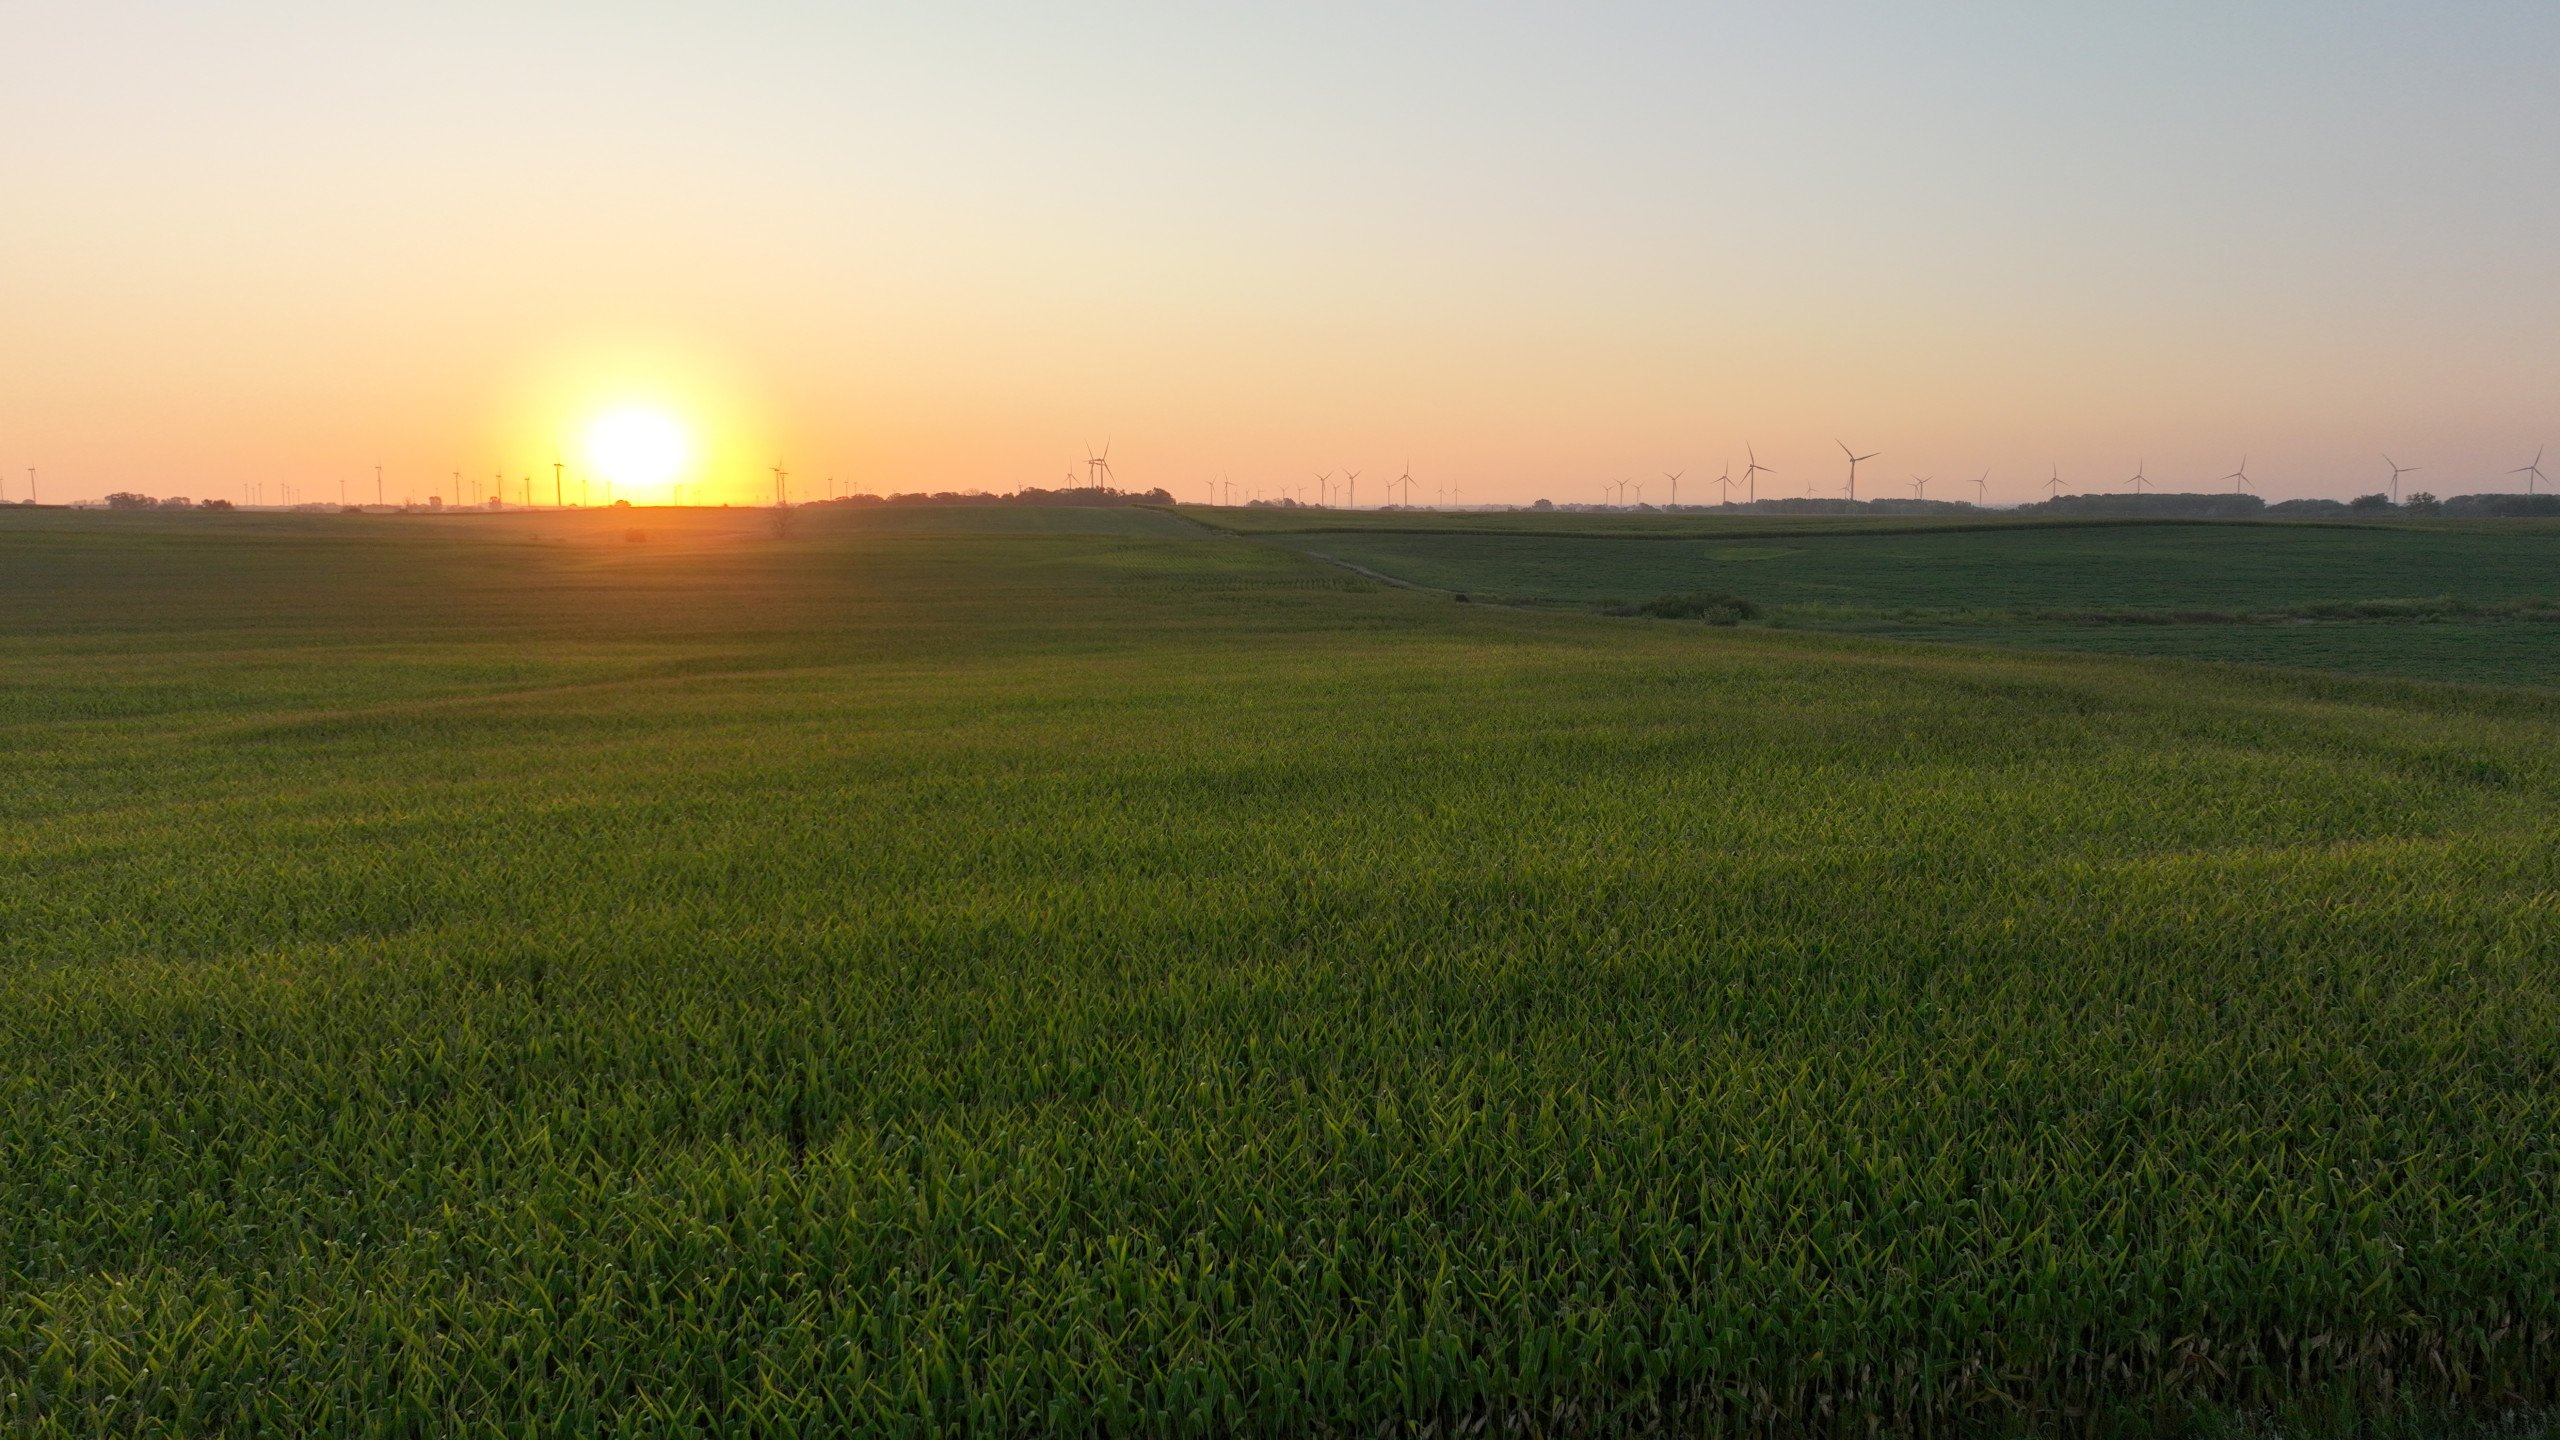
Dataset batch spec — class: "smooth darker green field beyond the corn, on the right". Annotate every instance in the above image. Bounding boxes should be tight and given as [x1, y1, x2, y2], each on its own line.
[1244, 512, 2560, 684]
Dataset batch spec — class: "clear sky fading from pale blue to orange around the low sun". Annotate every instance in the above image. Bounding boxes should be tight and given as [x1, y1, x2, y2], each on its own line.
[0, 0, 2560, 505]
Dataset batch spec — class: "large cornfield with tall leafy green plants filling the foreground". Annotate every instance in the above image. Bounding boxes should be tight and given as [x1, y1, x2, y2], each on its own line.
[0, 510, 2560, 1435]
